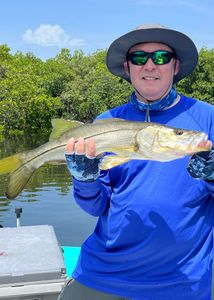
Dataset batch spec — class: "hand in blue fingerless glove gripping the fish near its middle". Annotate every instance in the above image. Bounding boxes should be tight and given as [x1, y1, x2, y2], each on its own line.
[65, 137, 101, 182]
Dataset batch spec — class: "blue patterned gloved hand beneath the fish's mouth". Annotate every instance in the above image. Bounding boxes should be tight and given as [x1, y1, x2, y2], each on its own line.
[187, 148, 214, 180]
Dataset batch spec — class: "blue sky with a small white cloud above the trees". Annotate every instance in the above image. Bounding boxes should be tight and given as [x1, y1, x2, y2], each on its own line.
[0, 0, 214, 61]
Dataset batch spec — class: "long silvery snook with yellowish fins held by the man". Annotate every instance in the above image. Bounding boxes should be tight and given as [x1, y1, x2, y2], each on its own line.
[0, 118, 212, 199]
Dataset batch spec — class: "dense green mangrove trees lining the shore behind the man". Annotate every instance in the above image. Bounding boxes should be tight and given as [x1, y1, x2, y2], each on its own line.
[0, 45, 214, 136]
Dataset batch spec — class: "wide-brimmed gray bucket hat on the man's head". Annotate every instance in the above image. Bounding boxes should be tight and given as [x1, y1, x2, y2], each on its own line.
[106, 24, 198, 83]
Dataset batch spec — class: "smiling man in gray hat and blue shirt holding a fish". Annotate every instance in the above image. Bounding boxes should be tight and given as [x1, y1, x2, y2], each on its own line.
[60, 25, 214, 300]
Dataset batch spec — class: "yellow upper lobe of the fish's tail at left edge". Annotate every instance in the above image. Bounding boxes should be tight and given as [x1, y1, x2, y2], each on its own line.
[0, 154, 22, 175]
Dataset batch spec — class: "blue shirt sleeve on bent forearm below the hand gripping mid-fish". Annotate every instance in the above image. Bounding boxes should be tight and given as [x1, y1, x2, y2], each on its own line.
[73, 171, 112, 217]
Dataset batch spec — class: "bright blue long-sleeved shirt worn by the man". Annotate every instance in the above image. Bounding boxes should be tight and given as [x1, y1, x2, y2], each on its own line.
[73, 96, 214, 300]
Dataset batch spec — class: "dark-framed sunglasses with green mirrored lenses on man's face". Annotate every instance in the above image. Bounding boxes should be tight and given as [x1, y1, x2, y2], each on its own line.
[127, 50, 176, 66]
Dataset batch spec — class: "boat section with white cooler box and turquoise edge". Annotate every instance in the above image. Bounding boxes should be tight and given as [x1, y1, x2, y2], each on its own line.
[0, 210, 80, 300]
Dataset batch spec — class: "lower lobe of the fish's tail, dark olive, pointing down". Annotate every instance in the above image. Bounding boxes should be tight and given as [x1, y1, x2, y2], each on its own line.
[5, 164, 36, 199]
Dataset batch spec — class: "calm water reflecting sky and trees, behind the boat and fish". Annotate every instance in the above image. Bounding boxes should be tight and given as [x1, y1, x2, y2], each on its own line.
[0, 138, 96, 246]
